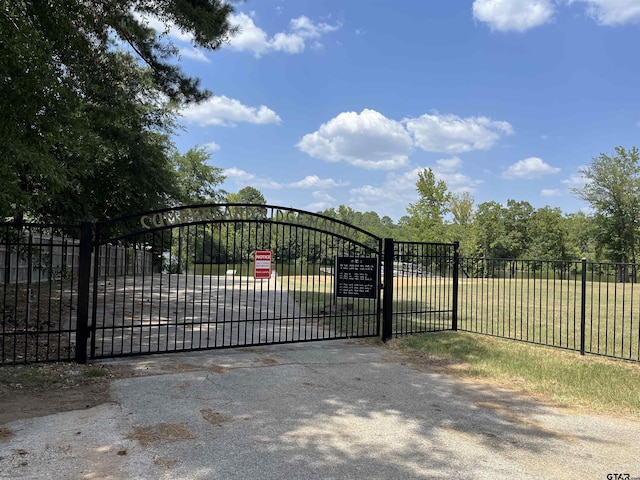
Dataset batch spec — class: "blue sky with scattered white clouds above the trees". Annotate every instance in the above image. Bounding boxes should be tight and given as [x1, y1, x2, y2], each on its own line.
[152, 0, 640, 221]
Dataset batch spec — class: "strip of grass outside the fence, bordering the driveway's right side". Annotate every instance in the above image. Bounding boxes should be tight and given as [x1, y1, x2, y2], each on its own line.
[390, 332, 640, 418]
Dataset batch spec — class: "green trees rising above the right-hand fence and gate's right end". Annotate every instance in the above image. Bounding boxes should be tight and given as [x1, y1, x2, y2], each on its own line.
[322, 147, 640, 263]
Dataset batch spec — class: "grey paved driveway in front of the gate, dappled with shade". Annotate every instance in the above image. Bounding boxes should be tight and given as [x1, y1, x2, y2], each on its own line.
[0, 341, 640, 480]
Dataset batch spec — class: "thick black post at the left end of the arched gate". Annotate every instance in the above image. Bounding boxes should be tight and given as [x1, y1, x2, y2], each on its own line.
[76, 222, 93, 363]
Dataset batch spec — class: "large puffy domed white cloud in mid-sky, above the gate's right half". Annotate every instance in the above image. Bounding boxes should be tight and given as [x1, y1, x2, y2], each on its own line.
[297, 109, 412, 170]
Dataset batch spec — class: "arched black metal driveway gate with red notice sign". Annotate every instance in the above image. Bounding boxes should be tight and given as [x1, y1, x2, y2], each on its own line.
[90, 204, 382, 358]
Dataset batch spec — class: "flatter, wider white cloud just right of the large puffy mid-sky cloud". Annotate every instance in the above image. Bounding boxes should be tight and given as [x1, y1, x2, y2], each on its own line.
[403, 113, 513, 153]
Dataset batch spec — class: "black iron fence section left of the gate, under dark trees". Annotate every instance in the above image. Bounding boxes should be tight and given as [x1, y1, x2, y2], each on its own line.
[0, 224, 79, 364]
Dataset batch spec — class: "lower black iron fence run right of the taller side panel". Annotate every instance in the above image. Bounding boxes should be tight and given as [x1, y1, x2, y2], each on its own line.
[458, 258, 640, 361]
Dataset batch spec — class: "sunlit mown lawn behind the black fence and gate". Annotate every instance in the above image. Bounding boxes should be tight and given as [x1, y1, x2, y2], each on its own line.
[281, 275, 640, 361]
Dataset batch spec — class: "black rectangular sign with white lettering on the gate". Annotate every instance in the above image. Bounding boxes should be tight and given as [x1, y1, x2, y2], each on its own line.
[335, 257, 379, 298]
